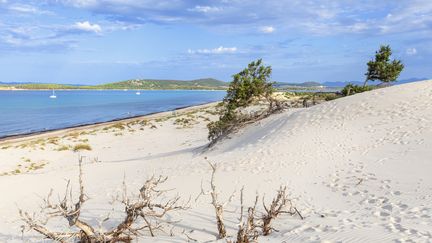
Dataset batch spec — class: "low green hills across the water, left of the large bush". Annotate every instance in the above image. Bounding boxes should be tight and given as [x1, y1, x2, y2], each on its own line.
[0, 78, 229, 90]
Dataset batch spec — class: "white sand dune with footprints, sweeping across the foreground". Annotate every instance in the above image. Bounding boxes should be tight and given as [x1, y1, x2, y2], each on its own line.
[0, 81, 432, 242]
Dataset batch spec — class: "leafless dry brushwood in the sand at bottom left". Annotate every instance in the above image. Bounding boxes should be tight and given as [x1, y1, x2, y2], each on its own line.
[19, 158, 188, 243]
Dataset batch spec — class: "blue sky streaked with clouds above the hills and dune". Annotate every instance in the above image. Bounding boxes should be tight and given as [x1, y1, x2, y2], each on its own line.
[0, 0, 432, 84]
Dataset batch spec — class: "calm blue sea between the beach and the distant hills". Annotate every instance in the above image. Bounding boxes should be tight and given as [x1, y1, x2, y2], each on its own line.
[0, 90, 225, 137]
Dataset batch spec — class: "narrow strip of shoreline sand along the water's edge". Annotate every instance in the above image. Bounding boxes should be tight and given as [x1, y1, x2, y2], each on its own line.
[0, 101, 221, 145]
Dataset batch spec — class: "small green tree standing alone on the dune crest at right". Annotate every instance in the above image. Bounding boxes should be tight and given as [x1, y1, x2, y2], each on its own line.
[363, 45, 404, 86]
